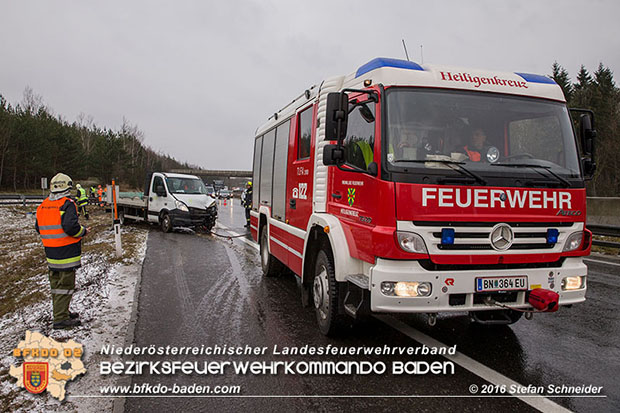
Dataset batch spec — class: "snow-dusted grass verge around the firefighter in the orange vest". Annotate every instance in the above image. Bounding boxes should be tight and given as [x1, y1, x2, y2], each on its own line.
[0, 207, 148, 412]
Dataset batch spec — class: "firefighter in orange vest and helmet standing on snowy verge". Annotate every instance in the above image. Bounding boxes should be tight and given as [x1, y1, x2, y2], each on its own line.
[35, 173, 88, 329]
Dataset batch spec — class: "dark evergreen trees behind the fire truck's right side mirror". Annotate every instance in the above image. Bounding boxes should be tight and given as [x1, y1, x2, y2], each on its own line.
[552, 62, 620, 196]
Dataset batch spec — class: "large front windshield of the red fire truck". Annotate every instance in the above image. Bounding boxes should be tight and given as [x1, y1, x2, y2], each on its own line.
[383, 87, 583, 187]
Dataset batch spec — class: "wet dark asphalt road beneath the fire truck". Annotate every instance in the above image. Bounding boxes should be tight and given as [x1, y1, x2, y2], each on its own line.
[125, 200, 620, 412]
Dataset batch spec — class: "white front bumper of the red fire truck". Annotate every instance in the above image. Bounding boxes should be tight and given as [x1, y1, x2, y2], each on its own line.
[370, 257, 588, 313]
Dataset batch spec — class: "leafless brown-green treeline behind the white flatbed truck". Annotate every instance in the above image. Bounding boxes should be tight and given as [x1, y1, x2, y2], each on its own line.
[0, 88, 196, 192]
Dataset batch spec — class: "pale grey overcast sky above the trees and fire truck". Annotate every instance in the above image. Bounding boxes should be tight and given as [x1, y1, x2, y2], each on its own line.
[0, 0, 620, 170]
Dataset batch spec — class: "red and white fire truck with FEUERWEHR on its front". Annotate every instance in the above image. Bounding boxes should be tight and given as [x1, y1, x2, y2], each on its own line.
[250, 58, 595, 334]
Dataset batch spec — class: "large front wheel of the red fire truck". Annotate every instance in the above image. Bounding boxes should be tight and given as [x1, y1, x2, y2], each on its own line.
[312, 250, 344, 336]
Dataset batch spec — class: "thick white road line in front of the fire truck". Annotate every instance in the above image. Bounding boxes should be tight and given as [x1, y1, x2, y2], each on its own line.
[373, 314, 570, 412]
